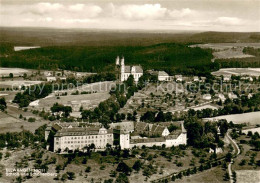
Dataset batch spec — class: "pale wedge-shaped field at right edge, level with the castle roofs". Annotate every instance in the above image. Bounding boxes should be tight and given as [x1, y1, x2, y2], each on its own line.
[205, 111, 260, 125]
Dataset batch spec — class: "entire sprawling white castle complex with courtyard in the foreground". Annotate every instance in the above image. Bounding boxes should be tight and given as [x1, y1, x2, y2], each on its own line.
[45, 122, 187, 152]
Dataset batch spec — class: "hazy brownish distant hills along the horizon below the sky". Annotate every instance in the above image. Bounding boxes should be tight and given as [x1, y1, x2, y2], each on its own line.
[0, 27, 260, 46]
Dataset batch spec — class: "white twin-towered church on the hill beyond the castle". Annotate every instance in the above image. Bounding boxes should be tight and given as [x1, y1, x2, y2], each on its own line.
[116, 56, 143, 82]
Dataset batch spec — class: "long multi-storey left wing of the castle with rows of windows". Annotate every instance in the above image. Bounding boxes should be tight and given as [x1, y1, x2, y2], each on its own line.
[45, 123, 114, 152]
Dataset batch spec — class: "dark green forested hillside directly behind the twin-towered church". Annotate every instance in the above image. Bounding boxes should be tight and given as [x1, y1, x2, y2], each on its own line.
[1, 43, 215, 72]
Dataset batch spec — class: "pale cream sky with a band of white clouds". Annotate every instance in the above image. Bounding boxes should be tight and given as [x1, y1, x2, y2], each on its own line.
[0, 0, 260, 32]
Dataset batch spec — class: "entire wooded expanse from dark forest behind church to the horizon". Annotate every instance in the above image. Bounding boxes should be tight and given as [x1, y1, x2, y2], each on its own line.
[0, 28, 260, 75]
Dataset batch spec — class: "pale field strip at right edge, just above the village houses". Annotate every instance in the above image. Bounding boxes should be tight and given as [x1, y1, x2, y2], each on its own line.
[212, 68, 260, 77]
